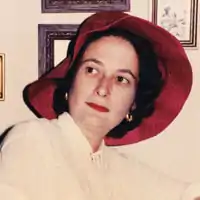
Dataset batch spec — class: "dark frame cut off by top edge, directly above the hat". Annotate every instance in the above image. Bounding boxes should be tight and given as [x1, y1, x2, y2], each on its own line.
[42, 0, 130, 13]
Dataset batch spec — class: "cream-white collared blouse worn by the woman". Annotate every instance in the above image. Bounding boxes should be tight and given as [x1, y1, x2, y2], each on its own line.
[0, 113, 200, 200]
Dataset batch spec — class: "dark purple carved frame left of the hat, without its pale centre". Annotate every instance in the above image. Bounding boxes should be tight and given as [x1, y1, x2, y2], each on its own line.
[38, 24, 79, 77]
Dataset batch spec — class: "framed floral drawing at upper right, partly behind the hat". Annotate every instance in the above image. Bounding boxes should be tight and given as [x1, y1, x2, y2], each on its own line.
[150, 0, 198, 48]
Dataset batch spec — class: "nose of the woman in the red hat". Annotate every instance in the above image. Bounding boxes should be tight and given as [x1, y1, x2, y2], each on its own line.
[95, 77, 111, 97]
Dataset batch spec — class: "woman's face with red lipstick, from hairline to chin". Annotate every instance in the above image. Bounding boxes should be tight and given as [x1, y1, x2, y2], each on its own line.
[69, 36, 139, 132]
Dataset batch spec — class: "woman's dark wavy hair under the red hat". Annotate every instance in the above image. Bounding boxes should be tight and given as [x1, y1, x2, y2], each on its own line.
[53, 28, 164, 138]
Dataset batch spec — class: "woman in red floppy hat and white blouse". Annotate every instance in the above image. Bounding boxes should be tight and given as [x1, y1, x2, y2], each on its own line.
[0, 12, 200, 200]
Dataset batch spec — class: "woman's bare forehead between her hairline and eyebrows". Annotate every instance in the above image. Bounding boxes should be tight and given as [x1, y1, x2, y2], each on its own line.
[83, 36, 138, 71]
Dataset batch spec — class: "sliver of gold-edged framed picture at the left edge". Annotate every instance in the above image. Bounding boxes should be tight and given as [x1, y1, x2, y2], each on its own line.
[0, 53, 5, 101]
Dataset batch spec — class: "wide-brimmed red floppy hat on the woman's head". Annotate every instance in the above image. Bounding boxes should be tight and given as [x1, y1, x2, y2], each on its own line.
[24, 11, 192, 146]
